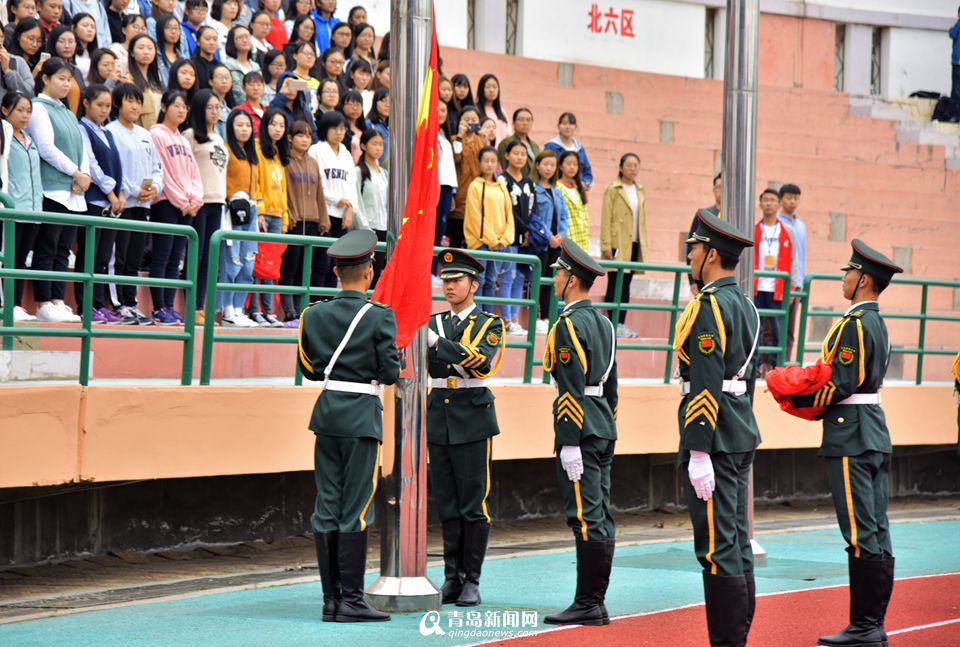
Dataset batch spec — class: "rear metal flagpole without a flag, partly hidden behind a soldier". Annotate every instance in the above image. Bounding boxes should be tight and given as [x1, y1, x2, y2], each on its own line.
[722, 0, 766, 555]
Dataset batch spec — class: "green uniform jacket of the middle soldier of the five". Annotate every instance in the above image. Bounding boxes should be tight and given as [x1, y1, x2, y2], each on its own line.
[543, 299, 618, 449]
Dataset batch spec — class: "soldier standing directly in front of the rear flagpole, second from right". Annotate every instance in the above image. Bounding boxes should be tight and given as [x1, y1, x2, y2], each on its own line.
[674, 215, 760, 646]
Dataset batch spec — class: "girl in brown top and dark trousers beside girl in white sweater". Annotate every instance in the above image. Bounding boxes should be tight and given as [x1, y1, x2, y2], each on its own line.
[280, 121, 330, 320]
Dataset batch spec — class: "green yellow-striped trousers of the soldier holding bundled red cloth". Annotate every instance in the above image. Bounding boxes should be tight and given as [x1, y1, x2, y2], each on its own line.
[826, 451, 893, 560]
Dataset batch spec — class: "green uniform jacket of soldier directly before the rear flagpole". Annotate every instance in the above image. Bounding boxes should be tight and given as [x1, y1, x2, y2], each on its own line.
[674, 277, 760, 463]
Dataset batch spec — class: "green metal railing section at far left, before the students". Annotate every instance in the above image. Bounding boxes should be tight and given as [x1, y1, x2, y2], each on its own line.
[0, 193, 199, 386]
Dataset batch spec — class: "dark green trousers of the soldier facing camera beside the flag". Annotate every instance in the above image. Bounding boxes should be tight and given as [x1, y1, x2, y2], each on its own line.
[427, 438, 493, 523]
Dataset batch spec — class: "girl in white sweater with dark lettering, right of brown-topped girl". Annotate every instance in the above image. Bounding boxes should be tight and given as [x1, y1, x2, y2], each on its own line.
[310, 112, 357, 287]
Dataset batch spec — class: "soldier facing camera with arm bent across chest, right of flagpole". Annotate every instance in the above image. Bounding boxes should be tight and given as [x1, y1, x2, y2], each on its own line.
[427, 249, 505, 607]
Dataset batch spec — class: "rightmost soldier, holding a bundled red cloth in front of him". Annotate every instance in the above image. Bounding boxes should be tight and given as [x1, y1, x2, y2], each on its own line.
[791, 240, 903, 647]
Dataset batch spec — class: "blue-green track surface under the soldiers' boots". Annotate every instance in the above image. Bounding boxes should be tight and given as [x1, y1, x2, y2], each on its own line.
[0, 520, 960, 647]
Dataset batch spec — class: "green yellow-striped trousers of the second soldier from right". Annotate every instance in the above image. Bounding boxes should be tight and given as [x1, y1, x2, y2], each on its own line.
[683, 452, 754, 576]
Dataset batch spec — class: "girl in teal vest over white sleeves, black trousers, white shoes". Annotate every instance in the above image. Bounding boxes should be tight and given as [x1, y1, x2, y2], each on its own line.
[27, 57, 90, 323]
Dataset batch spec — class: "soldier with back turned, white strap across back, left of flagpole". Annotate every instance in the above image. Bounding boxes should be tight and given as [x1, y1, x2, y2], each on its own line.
[298, 230, 400, 622]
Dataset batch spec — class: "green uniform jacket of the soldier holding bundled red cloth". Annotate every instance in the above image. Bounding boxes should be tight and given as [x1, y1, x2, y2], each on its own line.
[792, 301, 893, 456]
